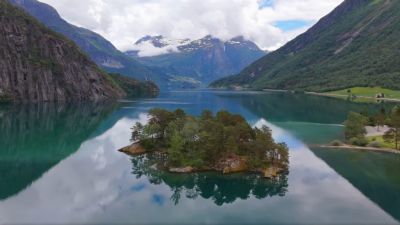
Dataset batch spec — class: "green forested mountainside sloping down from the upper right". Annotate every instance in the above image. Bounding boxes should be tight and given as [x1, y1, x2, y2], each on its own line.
[211, 0, 400, 91]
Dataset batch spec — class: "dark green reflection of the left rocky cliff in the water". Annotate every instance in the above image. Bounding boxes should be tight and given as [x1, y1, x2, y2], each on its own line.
[0, 103, 115, 200]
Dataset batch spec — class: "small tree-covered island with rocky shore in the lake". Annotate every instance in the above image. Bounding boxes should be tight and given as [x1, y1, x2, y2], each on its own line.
[120, 108, 289, 178]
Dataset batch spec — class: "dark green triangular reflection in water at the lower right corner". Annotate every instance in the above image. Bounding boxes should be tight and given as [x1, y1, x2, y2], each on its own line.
[312, 149, 400, 221]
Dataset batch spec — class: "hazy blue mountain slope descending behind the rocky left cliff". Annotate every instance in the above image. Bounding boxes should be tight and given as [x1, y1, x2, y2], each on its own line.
[9, 0, 166, 86]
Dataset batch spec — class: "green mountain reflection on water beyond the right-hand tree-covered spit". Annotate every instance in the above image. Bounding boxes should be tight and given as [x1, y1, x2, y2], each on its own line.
[219, 92, 392, 124]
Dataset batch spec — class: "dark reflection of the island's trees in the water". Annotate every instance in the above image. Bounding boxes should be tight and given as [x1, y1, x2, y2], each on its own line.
[131, 154, 288, 206]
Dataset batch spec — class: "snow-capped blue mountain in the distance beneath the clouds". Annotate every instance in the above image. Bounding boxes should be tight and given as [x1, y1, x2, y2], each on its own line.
[126, 35, 266, 87]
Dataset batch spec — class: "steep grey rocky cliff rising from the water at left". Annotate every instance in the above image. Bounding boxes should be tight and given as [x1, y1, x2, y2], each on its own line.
[0, 0, 125, 102]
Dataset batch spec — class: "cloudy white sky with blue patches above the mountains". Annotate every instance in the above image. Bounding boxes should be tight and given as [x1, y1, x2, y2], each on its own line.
[40, 0, 343, 54]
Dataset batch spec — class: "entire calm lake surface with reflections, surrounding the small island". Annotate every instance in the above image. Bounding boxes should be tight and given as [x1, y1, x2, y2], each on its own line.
[0, 92, 400, 224]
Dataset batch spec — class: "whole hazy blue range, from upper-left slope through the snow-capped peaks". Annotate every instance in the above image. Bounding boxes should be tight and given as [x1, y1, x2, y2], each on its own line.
[9, 0, 266, 90]
